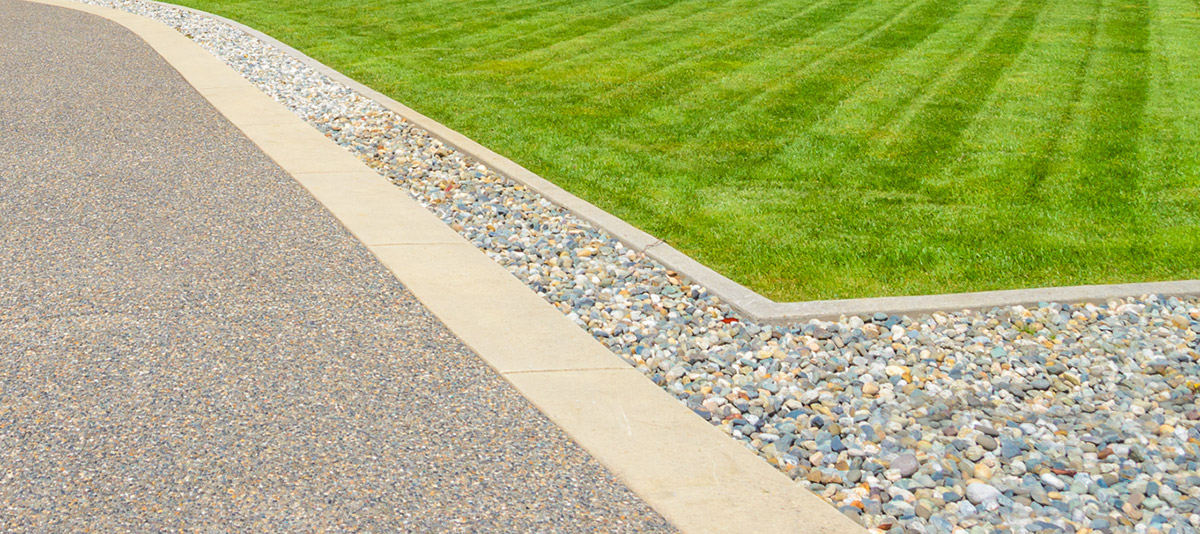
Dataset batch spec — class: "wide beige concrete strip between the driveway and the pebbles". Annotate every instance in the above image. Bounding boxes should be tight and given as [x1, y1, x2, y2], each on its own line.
[32, 0, 863, 534]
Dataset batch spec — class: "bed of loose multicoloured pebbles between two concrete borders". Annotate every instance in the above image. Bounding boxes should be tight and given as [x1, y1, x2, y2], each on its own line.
[77, 0, 1200, 534]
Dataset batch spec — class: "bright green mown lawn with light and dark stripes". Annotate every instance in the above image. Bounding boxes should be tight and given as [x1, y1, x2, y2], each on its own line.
[180, 0, 1200, 300]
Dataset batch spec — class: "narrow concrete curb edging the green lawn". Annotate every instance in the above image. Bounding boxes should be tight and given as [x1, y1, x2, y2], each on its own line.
[159, 0, 1200, 324]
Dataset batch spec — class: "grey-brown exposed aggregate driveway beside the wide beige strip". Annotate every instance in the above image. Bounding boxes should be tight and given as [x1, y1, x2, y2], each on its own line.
[0, 0, 671, 533]
